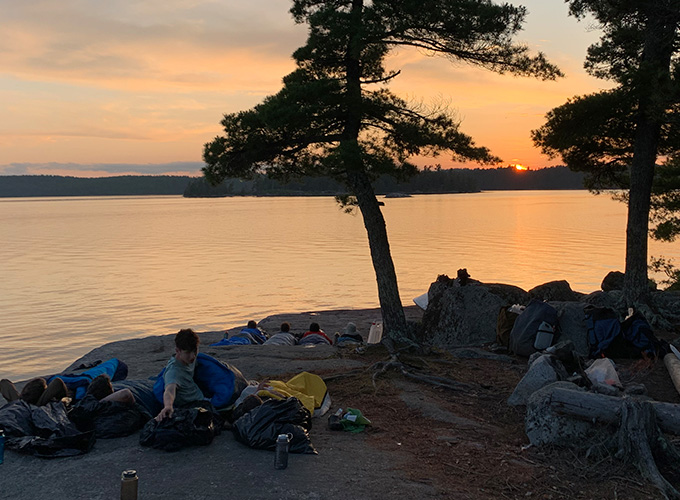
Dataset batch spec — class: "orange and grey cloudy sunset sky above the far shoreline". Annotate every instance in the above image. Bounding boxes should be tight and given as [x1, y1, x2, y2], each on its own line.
[0, 0, 607, 176]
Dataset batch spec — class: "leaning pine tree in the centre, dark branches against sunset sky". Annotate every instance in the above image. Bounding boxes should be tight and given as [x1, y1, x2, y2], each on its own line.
[203, 0, 560, 336]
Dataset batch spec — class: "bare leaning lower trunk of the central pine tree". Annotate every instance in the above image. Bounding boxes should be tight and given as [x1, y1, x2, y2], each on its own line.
[348, 171, 406, 337]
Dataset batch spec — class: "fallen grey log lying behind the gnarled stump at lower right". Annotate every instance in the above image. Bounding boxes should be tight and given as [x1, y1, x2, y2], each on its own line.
[549, 388, 680, 435]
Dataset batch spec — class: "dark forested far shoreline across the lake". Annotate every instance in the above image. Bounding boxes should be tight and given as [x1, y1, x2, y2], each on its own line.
[0, 167, 583, 197]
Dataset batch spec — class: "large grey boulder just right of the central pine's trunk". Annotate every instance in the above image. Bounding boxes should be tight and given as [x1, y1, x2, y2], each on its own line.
[422, 276, 507, 347]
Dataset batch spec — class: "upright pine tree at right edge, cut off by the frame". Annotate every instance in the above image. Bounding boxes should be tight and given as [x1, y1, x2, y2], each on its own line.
[533, 0, 680, 306]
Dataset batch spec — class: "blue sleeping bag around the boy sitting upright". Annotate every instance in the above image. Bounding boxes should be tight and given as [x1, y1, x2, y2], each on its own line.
[153, 352, 248, 408]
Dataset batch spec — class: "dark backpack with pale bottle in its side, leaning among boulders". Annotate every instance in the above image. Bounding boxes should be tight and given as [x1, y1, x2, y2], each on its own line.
[508, 299, 559, 356]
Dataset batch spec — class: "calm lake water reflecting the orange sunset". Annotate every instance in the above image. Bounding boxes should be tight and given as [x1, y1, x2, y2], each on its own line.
[0, 191, 680, 379]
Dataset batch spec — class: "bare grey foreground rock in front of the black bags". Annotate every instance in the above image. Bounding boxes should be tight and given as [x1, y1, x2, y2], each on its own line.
[0, 419, 441, 500]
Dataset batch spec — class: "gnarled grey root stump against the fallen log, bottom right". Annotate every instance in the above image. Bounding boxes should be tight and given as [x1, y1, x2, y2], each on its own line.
[616, 400, 680, 499]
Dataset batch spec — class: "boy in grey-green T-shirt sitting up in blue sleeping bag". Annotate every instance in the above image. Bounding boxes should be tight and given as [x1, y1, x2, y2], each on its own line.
[154, 329, 247, 421]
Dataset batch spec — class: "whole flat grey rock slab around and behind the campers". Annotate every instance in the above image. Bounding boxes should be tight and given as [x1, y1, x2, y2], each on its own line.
[0, 308, 441, 500]
